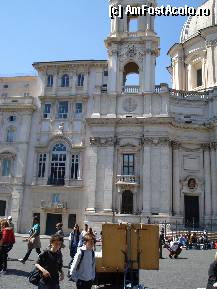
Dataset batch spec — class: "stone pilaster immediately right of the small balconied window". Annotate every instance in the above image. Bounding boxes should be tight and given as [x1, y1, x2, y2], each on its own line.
[142, 139, 151, 215]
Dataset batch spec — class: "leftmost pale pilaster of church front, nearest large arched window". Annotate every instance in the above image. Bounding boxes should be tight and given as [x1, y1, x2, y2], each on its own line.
[86, 138, 98, 212]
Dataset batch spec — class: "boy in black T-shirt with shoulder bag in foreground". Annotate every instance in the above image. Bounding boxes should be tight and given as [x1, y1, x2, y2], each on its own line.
[35, 235, 64, 289]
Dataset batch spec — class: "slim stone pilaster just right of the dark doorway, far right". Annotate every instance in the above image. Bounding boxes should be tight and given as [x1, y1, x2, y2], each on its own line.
[202, 144, 213, 217]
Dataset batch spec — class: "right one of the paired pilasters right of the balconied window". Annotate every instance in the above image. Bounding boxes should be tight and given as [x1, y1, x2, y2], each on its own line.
[159, 138, 172, 215]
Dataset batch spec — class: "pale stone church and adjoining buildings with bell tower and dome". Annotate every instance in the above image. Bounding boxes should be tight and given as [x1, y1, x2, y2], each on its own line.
[0, 0, 217, 234]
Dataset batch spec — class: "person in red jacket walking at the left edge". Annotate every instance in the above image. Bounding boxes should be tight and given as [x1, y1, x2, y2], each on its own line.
[0, 220, 15, 274]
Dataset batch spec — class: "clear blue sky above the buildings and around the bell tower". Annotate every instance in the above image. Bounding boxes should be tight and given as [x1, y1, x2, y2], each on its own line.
[0, 0, 204, 84]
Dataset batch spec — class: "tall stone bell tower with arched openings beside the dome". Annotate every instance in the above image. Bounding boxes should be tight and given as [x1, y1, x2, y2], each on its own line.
[105, 0, 159, 94]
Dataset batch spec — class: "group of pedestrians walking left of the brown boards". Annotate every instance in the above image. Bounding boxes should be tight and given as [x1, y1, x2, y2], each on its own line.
[0, 217, 96, 289]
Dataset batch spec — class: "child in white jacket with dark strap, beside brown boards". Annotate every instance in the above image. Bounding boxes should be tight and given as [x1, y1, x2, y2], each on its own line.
[70, 234, 95, 289]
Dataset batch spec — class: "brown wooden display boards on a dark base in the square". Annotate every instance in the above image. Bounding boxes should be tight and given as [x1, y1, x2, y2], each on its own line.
[96, 224, 159, 289]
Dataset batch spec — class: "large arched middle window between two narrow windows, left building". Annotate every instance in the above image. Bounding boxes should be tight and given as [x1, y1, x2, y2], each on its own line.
[48, 144, 66, 186]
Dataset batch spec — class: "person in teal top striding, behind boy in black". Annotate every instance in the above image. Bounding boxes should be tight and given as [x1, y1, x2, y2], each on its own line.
[18, 217, 41, 264]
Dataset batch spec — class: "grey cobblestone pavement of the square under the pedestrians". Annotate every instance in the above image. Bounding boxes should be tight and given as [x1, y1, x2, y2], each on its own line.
[0, 238, 215, 289]
